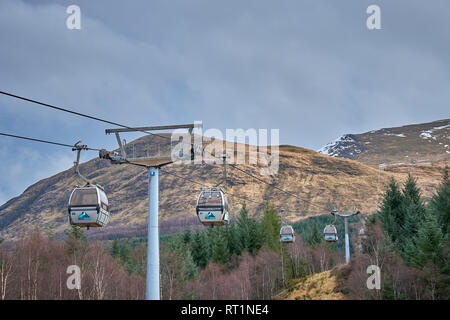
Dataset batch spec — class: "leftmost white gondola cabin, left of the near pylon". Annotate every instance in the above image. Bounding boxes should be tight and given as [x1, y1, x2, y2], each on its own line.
[69, 185, 109, 228]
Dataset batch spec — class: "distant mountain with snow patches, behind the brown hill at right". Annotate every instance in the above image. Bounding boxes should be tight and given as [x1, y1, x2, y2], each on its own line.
[318, 119, 450, 166]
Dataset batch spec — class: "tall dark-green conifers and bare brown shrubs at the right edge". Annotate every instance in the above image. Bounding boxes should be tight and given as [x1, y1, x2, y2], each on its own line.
[340, 167, 450, 300]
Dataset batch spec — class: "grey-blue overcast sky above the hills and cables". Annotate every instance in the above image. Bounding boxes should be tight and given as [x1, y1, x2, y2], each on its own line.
[0, 0, 450, 204]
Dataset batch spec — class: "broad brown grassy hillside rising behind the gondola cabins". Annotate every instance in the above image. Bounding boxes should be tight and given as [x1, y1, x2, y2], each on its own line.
[0, 129, 446, 239]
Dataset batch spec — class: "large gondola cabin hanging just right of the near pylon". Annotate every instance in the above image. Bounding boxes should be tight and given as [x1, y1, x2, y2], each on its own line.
[196, 187, 230, 226]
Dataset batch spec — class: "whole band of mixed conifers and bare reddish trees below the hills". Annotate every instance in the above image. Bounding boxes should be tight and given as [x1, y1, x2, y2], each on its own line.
[0, 168, 450, 300]
